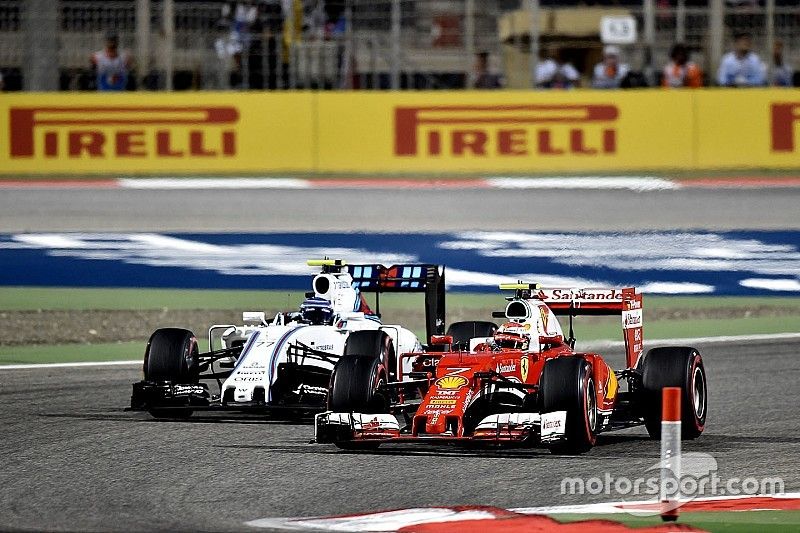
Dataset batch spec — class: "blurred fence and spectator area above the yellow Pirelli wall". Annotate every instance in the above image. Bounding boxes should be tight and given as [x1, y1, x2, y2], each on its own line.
[0, 0, 800, 91]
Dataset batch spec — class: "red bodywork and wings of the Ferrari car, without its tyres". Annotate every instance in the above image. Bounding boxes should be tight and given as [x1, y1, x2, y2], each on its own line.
[318, 288, 642, 442]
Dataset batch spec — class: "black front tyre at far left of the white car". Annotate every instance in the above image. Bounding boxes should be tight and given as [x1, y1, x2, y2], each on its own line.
[144, 328, 200, 418]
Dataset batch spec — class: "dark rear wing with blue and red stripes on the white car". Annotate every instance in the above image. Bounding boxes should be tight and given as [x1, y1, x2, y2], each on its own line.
[347, 264, 445, 339]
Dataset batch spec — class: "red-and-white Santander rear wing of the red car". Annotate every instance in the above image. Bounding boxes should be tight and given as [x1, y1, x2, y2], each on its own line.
[500, 283, 643, 368]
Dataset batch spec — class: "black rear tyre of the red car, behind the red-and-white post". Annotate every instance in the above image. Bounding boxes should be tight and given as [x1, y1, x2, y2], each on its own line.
[641, 346, 708, 439]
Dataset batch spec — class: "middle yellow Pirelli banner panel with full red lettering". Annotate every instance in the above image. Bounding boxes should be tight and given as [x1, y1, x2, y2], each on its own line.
[319, 90, 694, 173]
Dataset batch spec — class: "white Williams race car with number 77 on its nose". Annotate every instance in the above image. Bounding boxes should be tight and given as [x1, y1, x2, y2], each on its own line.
[131, 259, 445, 417]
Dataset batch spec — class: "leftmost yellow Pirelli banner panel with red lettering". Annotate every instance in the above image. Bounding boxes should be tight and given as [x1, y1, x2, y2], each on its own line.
[0, 92, 315, 174]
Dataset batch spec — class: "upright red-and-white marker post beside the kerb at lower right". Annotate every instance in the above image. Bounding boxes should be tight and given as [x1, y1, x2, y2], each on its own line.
[660, 387, 681, 522]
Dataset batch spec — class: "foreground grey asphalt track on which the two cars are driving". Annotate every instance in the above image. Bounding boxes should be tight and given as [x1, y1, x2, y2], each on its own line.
[0, 341, 800, 531]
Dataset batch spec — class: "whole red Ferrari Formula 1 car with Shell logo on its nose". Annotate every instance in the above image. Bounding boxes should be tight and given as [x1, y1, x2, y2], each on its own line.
[315, 283, 707, 454]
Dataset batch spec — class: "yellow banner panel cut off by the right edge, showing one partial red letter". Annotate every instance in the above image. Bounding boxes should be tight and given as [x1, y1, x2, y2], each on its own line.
[694, 89, 800, 168]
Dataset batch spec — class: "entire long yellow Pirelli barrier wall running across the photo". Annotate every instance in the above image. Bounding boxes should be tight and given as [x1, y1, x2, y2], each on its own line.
[0, 89, 800, 176]
